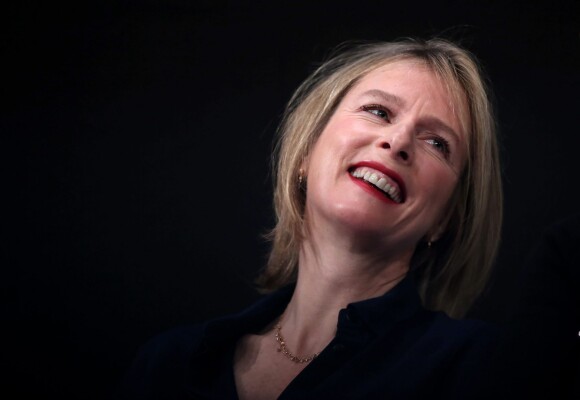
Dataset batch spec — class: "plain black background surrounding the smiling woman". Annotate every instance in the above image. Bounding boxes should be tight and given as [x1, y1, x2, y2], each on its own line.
[0, 0, 580, 399]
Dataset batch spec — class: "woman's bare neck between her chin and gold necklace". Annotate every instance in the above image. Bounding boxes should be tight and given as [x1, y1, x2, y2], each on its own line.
[281, 234, 411, 354]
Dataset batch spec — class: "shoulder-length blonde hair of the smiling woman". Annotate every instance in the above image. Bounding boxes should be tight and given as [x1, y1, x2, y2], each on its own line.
[257, 39, 503, 317]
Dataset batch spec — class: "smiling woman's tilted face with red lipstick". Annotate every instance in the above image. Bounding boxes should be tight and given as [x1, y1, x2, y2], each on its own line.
[303, 61, 466, 254]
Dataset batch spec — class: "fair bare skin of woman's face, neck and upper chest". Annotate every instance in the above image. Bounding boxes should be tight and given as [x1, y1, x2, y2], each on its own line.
[234, 61, 466, 400]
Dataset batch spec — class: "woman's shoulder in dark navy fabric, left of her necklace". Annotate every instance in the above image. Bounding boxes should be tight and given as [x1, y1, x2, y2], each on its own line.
[115, 290, 291, 400]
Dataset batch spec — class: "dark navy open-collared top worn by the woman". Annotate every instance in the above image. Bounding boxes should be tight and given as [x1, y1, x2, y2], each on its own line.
[117, 277, 498, 400]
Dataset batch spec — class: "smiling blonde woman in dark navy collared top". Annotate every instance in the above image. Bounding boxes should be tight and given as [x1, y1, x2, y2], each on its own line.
[116, 39, 502, 399]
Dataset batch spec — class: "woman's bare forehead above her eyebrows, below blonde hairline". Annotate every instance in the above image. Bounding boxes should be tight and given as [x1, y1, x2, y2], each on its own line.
[347, 59, 470, 137]
